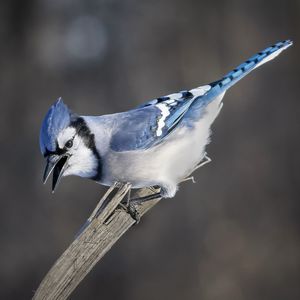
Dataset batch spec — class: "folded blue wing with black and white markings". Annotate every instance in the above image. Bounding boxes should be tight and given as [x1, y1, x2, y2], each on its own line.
[110, 85, 211, 151]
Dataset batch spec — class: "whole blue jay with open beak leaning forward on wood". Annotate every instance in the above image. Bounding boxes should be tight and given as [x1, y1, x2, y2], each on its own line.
[40, 40, 292, 198]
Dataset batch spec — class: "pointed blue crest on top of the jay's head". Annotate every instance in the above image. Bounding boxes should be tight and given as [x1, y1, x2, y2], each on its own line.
[40, 98, 71, 154]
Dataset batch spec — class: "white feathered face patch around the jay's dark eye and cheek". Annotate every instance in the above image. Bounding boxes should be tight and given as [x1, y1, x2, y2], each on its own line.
[57, 127, 98, 178]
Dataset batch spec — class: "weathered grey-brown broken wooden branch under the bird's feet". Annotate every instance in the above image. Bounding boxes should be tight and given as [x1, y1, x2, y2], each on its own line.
[33, 184, 161, 300]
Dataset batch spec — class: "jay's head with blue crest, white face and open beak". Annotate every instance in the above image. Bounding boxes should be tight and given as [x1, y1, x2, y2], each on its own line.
[40, 98, 101, 192]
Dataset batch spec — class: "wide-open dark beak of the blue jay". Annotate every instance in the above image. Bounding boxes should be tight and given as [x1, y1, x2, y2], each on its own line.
[43, 155, 69, 193]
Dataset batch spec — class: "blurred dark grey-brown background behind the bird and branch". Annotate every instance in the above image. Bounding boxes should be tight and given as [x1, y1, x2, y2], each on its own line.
[0, 0, 300, 300]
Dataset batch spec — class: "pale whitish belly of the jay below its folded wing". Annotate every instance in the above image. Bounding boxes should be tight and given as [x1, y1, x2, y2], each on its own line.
[104, 123, 210, 188]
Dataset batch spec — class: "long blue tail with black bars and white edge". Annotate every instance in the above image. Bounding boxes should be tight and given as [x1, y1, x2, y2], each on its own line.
[207, 40, 293, 98]
